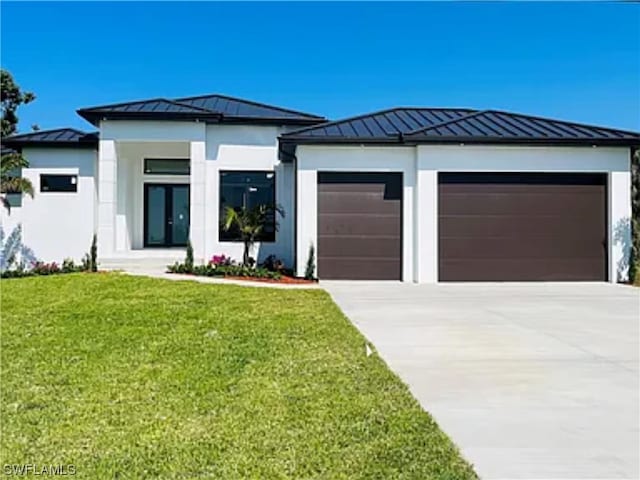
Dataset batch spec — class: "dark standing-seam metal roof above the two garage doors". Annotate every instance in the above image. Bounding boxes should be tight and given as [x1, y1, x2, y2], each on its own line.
[280, 108, 640, 146]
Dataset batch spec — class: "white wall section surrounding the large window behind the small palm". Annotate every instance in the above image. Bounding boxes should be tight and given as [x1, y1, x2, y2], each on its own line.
[204, 125, 295, 266]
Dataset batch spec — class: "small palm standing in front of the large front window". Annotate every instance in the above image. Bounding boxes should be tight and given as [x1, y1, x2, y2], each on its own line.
[223, 205, 284, 267]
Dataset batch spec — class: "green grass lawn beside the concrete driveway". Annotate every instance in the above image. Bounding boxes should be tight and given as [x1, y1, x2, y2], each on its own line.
[0, 274, 475, 480]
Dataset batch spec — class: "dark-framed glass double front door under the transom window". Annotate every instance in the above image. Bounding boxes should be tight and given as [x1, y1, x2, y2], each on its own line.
[144, 183, 189, 247]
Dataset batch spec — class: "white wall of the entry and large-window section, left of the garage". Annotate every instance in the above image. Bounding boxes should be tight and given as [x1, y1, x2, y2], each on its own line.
[98, 121, 294, 266]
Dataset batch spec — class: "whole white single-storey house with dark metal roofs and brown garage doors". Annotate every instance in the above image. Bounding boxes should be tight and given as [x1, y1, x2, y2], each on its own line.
[3, 95, 640, 283]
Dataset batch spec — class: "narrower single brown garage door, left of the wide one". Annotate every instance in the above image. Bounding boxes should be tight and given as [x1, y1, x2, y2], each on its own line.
[318, 173, 402, 280]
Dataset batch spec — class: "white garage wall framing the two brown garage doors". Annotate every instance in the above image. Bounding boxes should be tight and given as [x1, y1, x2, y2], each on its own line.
[296, 145, 631, 283]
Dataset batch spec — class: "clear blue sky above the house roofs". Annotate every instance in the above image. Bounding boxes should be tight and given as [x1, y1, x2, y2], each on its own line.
[0, 1, 640, 131]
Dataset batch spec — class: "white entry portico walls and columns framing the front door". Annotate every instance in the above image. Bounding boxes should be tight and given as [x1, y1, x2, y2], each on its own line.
[98, 120, 205, 258]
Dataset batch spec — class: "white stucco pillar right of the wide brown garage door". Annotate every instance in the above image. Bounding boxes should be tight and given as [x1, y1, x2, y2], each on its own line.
[609, 169, 631, 283]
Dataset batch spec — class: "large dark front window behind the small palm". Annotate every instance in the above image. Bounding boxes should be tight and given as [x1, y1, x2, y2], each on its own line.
[218, 171, 276, 242]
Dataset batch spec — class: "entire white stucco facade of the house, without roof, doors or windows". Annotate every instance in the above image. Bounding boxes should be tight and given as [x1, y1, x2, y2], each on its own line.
[2, 120, 631, 283]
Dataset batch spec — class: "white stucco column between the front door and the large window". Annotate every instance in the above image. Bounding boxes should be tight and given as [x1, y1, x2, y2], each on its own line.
[189, 139, 207, 261]
